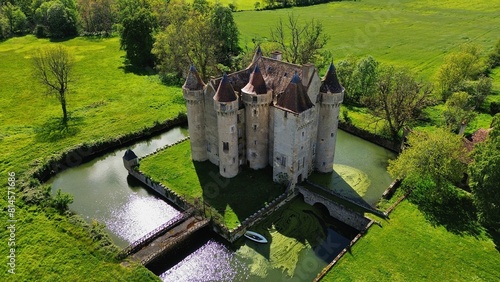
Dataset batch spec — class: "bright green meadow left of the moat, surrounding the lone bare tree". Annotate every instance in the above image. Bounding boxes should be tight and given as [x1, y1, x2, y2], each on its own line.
[0, 36, 185, 281]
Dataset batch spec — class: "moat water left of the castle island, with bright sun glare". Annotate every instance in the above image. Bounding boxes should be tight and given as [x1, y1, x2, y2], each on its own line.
[49, 127, 187, 247]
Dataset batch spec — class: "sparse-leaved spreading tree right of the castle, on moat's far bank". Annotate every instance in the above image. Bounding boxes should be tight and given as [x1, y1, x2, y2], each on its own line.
[366, 66, 432, 140]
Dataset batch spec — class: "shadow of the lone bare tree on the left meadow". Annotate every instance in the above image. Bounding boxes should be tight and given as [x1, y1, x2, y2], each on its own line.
[35, 117, 83, 143]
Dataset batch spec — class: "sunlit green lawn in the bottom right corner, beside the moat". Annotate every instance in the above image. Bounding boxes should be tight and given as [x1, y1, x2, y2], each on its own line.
[322, 201, 500, 281]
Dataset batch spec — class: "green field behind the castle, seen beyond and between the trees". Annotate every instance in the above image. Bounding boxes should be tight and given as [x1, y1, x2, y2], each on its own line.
[234, 0, 500, 134]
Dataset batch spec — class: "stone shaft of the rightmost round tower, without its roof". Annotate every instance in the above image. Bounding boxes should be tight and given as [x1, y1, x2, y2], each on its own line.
[315, 93, 343, 173]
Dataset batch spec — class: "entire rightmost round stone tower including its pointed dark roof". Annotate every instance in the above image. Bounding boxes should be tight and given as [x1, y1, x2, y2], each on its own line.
[316, 63, 344, 173]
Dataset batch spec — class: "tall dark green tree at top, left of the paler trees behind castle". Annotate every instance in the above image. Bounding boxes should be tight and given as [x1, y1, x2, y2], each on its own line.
[118, 0, 158, 67]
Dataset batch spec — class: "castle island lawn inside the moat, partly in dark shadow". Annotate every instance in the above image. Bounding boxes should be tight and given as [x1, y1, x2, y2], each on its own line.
[140, 141, 284, 229]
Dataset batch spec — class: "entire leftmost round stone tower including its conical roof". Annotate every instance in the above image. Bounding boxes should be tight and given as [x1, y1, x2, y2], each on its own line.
[182, 66, 208, 161]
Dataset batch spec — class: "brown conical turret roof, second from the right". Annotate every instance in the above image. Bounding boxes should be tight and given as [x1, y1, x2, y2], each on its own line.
[276, 73, 313, 113]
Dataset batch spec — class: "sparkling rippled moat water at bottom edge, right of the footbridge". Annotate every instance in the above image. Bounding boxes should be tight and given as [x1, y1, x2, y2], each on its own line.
[160, 240, 249, 282]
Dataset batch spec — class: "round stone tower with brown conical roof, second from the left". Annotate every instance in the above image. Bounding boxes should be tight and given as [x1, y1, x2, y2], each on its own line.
[214, 73, 239, 178]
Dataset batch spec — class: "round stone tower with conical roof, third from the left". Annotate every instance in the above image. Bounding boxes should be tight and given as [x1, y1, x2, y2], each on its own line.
[241, 66, 272, 169]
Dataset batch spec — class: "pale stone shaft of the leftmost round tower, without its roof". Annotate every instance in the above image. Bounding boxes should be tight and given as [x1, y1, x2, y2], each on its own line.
[183, 88, 208, 161]
